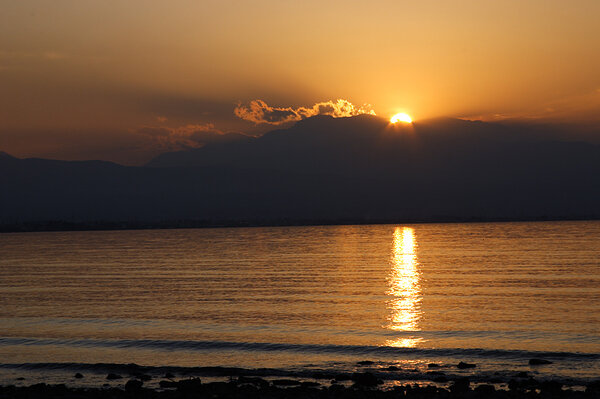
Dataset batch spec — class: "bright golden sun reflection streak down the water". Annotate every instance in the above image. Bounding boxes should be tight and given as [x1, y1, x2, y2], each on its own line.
[386, 227, 422, 348]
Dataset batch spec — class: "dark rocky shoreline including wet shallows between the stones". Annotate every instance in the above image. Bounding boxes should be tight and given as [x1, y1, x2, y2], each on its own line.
[0, 359, 600, 399]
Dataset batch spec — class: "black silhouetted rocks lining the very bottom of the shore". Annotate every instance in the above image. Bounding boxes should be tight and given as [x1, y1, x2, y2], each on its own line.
[0, 372, 600, 399]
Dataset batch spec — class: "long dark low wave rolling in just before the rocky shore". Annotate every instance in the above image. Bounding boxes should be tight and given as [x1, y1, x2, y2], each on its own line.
[0, 337, 600, 361]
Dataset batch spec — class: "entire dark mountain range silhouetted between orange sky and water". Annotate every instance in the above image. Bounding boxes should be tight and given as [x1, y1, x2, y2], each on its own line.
[0, 115, 600, 231]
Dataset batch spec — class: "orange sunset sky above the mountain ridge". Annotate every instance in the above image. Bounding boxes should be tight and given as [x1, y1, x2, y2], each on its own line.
[0, 0, 600, 165]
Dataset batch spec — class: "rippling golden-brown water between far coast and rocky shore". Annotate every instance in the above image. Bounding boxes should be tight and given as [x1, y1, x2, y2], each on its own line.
[0, 222, 600, 383]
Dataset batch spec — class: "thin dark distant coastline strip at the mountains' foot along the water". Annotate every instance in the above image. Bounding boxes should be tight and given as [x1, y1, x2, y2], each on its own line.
[0, 215, 600, 233]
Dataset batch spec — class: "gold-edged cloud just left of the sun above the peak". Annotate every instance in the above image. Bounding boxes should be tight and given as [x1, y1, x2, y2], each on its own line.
[234, 99, 375, 125]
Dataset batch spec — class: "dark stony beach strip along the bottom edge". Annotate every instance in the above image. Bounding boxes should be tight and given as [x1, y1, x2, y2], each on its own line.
[0, 365, 600, 399]
